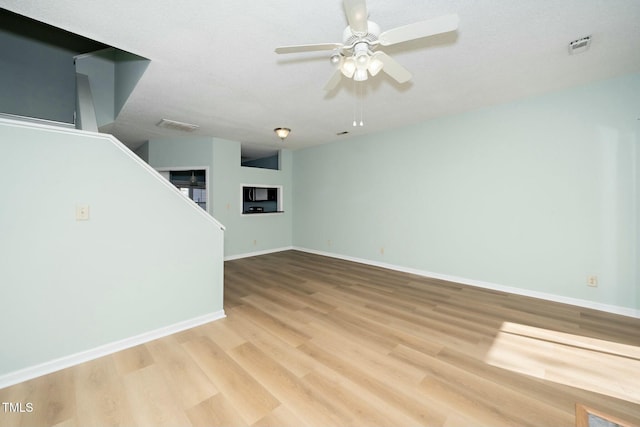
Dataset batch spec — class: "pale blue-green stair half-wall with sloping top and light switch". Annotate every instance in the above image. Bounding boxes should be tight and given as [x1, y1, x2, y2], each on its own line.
[0, 120, 223, 378]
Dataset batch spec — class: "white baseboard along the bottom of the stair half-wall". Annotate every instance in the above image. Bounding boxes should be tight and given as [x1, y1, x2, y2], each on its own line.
[0, 310, 226, 389]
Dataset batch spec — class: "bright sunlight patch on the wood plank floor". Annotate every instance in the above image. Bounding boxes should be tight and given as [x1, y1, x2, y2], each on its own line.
[484, 322, 640, 403]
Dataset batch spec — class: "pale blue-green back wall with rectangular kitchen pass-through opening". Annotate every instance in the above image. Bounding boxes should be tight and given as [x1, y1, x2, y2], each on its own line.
[144, 137, 293, 257]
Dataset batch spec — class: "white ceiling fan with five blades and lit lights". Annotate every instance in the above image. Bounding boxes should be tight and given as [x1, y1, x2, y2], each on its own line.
[276, 0, 459, 91]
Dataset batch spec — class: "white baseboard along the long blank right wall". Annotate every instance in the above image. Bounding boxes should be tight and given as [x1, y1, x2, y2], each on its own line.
[292, 246, 640, 319]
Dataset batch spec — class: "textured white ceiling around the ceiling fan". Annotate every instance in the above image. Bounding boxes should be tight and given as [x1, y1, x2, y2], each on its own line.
[0, 0, 640, 149]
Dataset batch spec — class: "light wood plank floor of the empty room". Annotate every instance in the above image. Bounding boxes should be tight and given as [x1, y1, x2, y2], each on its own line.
[0, 251, 640, 427]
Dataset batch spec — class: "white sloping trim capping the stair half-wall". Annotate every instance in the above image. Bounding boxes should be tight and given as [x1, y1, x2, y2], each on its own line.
[0, 117, 225, 230]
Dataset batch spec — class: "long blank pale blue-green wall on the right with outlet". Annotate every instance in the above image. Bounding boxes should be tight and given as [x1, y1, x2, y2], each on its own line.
[293, 75, 640, 308]
